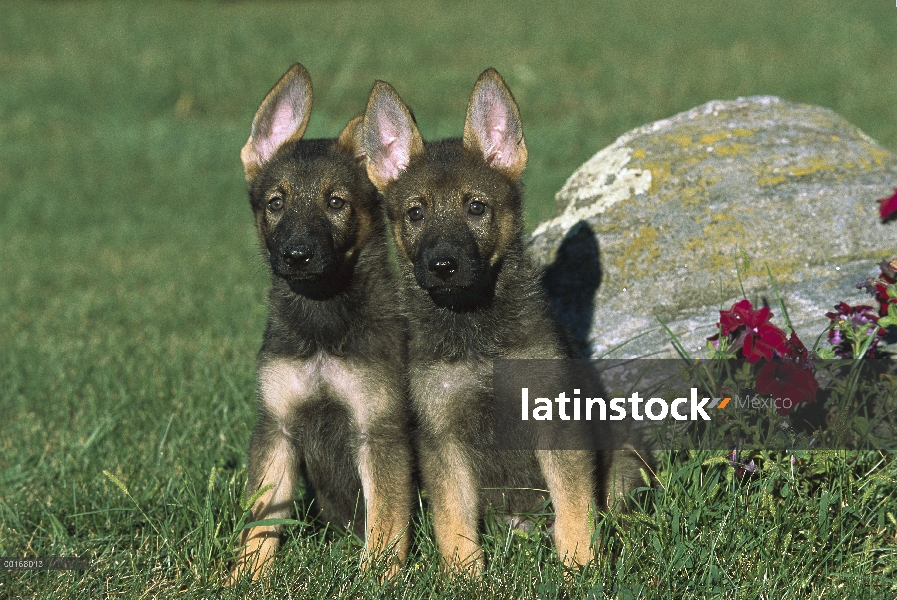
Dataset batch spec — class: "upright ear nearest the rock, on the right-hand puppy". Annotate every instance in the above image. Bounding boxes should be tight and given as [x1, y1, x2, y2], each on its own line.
[464, 69, 527, 180]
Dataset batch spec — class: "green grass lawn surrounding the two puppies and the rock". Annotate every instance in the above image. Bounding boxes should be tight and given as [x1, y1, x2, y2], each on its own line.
[0, 0, 897, 599]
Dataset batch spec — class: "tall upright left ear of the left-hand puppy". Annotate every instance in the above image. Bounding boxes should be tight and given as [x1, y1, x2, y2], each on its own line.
[240, 63, 311, 181]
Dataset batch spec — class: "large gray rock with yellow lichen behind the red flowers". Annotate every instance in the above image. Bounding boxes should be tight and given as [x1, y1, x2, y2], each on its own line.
[530, 97, 897, 358]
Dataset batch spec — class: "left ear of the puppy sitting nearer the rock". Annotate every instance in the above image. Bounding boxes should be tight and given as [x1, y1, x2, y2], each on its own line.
[362, 81, 424, 191]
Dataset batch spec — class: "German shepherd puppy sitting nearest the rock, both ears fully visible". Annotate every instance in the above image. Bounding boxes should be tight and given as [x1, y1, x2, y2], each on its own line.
[363, 69, 624, 572]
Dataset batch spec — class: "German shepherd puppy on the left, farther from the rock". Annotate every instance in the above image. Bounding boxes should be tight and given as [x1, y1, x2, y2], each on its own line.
[232, 64, 413, 580]
